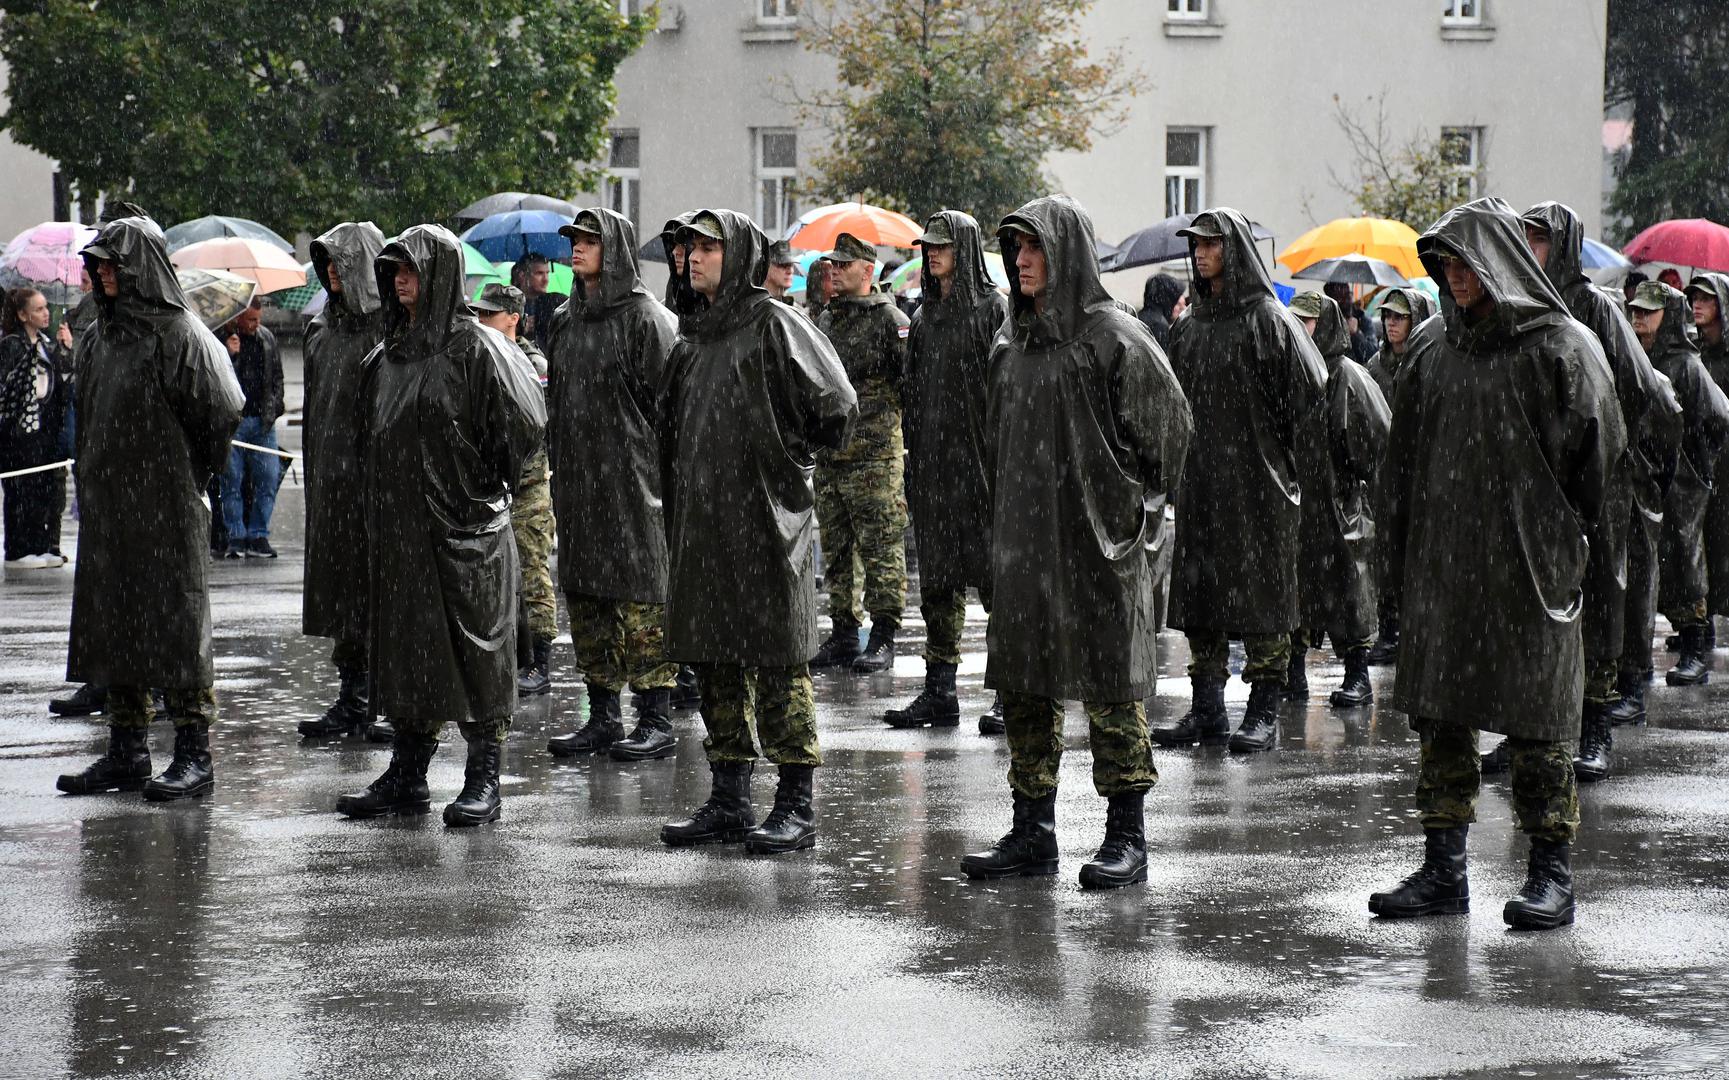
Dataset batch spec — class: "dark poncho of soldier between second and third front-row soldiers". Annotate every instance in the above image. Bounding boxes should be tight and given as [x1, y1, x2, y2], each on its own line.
[546, 209, 678, 603]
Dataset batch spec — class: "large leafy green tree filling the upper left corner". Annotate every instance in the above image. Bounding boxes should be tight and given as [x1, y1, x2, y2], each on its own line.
[0, 0, 654, 233]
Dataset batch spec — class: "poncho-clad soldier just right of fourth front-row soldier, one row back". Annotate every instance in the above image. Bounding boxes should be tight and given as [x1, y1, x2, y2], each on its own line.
[1153, 207, 1326, 752]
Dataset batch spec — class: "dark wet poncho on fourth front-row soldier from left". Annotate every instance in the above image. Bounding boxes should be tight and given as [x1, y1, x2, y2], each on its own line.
[986, 195, 1193, 703]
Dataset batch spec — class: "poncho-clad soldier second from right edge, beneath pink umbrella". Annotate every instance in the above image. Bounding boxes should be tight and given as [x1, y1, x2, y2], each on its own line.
[1629, 282, 1729, 686]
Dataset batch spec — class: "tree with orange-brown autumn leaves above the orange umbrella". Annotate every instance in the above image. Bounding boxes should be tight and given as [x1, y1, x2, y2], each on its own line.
[799, 0, 1143, 226]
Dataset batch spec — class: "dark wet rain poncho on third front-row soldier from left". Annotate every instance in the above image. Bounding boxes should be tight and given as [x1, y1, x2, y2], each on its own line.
[660, 211, 858, 667]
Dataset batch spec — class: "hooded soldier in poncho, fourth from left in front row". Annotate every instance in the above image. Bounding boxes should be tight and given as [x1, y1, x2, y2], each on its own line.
[961, 195, 1193, 888]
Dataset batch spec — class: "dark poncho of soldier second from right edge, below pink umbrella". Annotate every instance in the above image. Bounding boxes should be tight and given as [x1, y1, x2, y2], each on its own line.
[1641, 287, 1729, 612]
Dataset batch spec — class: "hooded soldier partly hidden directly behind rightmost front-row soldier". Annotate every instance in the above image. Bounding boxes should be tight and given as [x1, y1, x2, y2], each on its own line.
[1521, 202, 1682, 781]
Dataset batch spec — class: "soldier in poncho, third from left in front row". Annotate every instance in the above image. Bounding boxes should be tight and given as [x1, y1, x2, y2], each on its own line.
[659, 209, 858, 854]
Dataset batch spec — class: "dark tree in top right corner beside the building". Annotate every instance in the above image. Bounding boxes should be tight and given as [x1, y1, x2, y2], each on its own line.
[1605, 0, 1729, 240]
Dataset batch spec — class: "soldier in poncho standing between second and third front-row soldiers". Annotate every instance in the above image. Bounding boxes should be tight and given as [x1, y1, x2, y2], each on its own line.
[546, 207, 678, 760]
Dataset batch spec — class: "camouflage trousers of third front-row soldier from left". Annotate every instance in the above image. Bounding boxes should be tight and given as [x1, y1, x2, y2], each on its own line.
[695, 664, 823, 766]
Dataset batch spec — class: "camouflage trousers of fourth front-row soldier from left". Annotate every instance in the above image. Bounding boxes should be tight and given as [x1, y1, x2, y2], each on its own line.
[1003, 691, 1158, 798]
